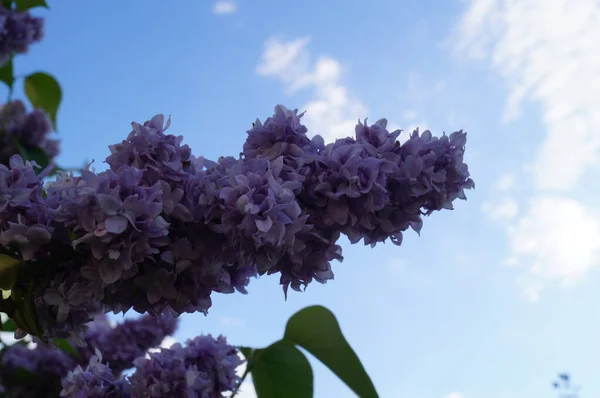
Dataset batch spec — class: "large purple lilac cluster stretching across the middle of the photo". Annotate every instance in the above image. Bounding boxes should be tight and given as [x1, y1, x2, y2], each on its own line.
[0, 106, 474, 337]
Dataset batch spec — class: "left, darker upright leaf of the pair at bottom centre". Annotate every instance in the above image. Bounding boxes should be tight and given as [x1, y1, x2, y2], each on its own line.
[250, 341, 313, 398]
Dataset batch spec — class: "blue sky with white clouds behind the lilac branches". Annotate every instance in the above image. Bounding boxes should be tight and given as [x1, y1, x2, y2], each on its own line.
[4, 0, 600, 398]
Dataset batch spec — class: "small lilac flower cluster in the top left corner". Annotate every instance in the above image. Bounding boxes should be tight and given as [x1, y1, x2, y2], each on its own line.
[0, 5, 44, 65]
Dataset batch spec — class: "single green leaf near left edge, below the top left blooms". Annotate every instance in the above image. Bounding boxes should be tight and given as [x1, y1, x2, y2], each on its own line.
[25, 72, 62, 129]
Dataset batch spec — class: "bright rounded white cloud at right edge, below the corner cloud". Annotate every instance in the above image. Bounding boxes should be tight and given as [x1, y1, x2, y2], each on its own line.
[508, 196, 600, 298]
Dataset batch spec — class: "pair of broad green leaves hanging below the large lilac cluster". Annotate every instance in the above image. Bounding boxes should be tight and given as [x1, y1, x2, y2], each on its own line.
[239, 306, 379, 398]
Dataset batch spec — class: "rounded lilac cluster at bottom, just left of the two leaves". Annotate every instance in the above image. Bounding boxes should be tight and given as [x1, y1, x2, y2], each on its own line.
[129, 335, 243, 398]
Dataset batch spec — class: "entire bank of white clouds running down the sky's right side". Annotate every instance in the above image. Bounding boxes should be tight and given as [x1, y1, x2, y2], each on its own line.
[453, 0, 600, 300]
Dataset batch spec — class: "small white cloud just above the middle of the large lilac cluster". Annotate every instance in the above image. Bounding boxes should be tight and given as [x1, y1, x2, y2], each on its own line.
[256, 37, 367, 141]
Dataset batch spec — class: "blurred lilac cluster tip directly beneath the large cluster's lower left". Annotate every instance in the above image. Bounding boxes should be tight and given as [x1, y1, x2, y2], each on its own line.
[80, 314, 178, 375]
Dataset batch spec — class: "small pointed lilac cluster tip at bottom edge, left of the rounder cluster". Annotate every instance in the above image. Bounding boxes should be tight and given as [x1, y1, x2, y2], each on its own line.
[60, 352, 129, 398]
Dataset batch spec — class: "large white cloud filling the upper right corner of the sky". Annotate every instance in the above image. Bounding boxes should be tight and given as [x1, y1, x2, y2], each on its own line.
[456, 0, 600, 191]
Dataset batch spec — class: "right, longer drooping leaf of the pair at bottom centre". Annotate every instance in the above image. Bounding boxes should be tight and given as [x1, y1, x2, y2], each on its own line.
[284, 306, 379, 398]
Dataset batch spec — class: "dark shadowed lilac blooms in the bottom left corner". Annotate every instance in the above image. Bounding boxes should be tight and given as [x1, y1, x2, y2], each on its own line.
[0, 344, 75, 398]
